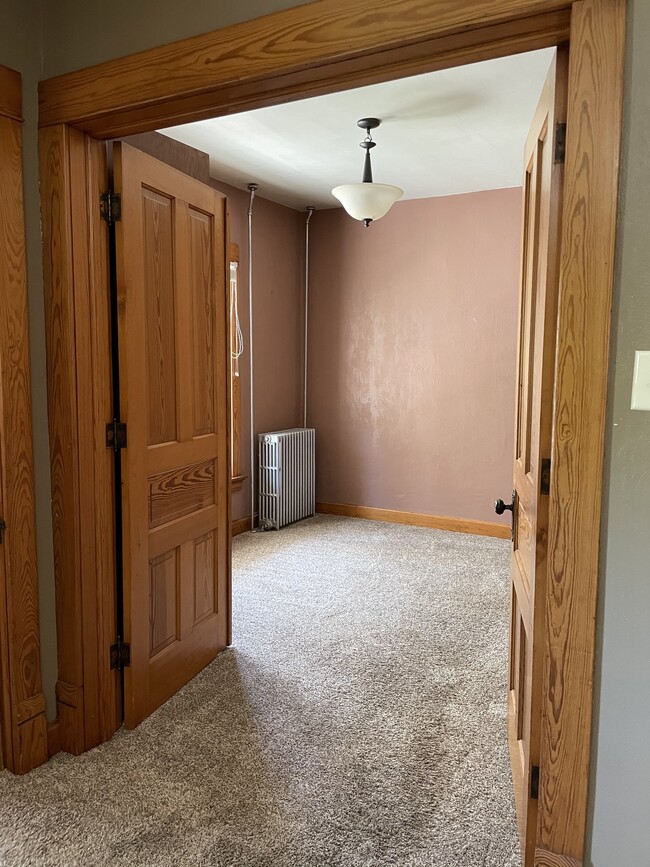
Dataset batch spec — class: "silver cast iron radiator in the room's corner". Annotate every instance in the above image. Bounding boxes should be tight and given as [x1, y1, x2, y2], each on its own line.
[258, 428, 316, 530]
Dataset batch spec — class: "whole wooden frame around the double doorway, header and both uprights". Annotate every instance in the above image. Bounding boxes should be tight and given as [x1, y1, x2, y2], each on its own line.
[35, 0, 625, 867]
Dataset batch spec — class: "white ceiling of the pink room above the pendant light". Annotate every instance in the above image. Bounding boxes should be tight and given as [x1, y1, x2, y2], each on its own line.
[160, 48, 555, 210]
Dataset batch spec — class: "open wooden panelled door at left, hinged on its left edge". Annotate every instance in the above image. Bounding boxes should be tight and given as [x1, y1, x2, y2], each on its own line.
[114, 144, 230, 728]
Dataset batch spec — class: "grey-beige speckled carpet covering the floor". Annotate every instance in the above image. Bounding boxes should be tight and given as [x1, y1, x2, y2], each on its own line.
[0, 516, 519, 867]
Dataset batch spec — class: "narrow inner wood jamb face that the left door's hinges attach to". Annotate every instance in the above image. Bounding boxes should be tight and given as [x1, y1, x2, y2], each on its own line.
[69, 130, 119, 749]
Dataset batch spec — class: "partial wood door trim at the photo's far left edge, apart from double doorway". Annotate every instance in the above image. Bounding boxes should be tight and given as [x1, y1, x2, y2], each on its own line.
[0, 66, 47, 773]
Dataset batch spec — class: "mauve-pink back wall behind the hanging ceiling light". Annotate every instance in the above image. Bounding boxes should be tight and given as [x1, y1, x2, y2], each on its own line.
[308, 189, 521, 523]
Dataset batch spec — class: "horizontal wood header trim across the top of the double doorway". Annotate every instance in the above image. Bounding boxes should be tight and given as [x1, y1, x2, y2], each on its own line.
[40, 0, 571, 138]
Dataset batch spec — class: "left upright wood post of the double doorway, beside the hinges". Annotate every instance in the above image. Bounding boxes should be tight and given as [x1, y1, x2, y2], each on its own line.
[40, 126, 120, 754]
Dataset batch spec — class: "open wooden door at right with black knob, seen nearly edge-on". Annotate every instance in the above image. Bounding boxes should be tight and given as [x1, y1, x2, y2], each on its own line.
[508, 50, 568, 867]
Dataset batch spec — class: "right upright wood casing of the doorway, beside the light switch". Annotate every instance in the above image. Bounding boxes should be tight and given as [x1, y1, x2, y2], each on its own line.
[538, 0, 625, 864]
